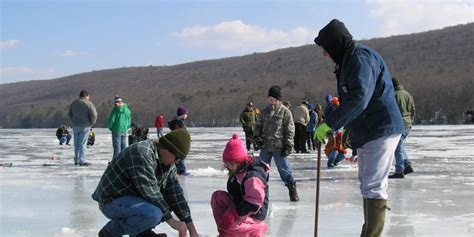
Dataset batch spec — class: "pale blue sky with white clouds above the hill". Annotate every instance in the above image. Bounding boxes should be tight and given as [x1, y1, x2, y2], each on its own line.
[0, 0, 474, 84]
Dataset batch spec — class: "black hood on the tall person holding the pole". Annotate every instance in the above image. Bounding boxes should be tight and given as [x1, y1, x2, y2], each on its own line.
[314, 19, 352, 65]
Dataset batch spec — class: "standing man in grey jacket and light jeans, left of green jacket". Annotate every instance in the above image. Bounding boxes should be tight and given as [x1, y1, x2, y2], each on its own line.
[68, 90, 97, 166]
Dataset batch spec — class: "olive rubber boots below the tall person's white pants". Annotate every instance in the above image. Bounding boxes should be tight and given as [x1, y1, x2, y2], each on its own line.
[361, 199, 388, 237]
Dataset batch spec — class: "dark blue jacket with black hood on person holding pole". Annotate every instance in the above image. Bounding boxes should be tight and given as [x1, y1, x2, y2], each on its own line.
[314, 19, 403, 149]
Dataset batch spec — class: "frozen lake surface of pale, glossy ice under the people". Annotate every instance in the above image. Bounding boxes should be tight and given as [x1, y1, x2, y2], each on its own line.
[0, 125, 474, 237]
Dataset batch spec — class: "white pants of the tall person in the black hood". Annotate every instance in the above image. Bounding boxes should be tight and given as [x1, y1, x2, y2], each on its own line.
[357, 134, 401, 199]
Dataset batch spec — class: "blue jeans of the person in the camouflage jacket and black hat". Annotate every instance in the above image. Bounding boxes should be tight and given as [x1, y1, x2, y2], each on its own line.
[260, 150, 295, 185]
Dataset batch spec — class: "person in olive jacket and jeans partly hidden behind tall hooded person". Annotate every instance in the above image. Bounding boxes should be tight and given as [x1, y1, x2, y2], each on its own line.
[388, 77, 415, 179]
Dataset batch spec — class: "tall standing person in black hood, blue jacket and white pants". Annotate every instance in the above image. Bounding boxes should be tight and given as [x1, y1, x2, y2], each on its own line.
[314, 19, 403, 237]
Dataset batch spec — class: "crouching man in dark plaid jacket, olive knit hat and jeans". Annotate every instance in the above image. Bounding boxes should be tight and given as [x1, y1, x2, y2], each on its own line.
[92, 129, 198, 237]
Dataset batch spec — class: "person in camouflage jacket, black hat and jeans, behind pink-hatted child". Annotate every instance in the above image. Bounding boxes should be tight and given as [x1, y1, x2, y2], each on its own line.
[253, 86, 300, 202]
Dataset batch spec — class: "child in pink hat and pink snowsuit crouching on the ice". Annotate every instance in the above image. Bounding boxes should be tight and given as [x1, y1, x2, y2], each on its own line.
[211, 134, 269, 237]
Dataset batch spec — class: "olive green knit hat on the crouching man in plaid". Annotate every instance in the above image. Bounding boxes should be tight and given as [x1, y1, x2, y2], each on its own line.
[158, 128, 191, 160]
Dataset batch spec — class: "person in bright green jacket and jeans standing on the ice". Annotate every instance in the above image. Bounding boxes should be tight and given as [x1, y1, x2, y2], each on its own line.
[109, 95, 132, 159]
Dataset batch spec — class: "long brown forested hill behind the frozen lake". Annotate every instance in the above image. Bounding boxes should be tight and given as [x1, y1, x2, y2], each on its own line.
[0, 23, 474, 128]
